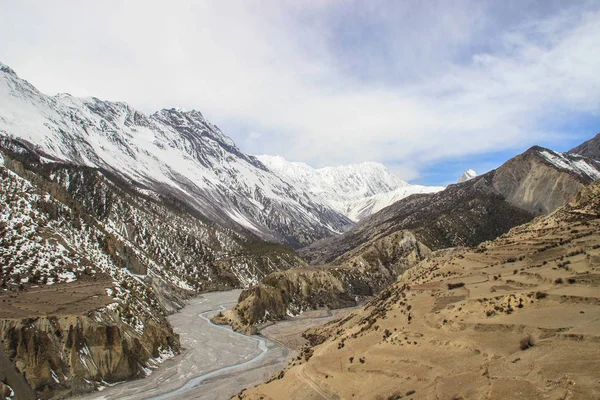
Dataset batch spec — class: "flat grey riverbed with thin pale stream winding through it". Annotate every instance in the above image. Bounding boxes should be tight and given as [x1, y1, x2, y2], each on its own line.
[82, 290, 290, 400]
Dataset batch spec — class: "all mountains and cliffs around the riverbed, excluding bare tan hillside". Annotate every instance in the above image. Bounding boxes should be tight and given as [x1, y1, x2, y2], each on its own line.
[0, 60, 600, 398]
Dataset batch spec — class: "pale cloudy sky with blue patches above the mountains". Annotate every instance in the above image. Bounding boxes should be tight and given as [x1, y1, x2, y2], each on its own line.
[0, 0, 600, 185]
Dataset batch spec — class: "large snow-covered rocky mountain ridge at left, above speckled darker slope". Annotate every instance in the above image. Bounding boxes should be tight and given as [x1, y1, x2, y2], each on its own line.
[0, 64, 351, 247]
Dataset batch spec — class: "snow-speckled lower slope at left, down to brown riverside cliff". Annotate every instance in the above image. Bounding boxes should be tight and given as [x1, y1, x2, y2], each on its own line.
[0, 137, 303, 398]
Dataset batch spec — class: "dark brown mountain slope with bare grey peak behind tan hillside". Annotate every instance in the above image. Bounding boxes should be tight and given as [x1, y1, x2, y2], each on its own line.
[300, 146, 600, 265]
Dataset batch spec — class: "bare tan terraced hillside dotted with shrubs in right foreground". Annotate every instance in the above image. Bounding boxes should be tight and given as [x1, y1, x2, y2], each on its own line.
[239, 183, 600, 399]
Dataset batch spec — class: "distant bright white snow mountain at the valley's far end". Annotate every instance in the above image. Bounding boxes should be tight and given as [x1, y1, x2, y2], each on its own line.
[256, 155, 444, 222]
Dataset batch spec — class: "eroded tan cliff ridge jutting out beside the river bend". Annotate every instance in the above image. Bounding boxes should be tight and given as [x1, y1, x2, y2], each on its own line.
[223, 232, 431, 332]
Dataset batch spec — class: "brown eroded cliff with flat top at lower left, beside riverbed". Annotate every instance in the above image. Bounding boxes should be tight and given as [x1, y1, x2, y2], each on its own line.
[0, 309, 179, 398]
